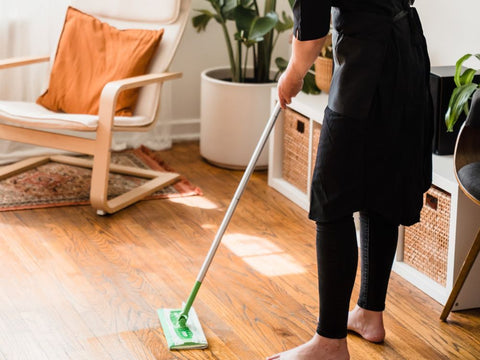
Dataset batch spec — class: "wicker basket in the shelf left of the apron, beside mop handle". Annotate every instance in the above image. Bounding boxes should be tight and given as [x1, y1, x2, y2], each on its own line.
[282, 108, 320, 193]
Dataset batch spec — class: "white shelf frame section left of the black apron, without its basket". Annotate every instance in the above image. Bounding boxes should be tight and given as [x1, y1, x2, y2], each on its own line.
[268, 89, 328, 210]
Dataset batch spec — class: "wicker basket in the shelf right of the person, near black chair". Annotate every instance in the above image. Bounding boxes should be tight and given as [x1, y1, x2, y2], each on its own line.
[403, 186, 451, 286]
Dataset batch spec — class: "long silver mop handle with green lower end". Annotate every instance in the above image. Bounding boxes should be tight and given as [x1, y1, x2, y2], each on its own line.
[181, 103, 281, 317]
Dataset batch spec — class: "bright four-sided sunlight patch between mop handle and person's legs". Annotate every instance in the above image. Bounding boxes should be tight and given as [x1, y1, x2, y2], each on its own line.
[222, 234, 305, 276]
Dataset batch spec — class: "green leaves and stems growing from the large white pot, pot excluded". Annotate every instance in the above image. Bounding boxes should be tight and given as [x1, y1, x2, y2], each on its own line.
[192, 0, 293, 83]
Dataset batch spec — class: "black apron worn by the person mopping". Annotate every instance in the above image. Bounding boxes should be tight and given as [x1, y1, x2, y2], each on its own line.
[309, 0, 433, 225]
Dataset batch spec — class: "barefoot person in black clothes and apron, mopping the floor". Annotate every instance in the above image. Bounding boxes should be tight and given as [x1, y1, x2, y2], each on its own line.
[268, 0, 433, 360]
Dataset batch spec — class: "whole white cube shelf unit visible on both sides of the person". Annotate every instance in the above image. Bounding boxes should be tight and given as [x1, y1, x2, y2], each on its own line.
[268, 89, 480, 311]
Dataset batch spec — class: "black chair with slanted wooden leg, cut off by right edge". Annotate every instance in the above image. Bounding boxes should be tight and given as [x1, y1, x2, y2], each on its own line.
[440, 90, 480, 321]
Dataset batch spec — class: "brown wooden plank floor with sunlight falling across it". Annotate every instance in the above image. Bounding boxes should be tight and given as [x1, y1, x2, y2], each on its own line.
[0, 143, 480, 360]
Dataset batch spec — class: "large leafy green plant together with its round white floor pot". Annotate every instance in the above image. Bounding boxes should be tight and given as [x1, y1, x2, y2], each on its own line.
[192, 0, 293, 168]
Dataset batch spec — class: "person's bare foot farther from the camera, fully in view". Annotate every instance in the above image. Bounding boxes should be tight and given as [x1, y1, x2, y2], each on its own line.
[347, 305, 385, 343]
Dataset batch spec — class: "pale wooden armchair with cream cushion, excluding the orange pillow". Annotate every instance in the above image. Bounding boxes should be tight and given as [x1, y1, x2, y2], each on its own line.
[0, 0, 191, 214]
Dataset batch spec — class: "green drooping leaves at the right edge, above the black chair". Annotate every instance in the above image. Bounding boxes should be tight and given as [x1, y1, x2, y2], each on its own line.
[445, 54, 480, 132]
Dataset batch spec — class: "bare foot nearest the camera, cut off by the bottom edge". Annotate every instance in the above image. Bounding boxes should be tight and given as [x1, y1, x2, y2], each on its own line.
[267, 334, 350, 360]
